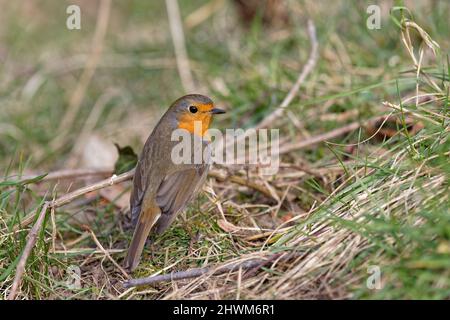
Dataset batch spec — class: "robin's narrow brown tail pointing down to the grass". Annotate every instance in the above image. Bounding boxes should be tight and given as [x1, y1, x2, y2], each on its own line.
[124, 212, 157, 272]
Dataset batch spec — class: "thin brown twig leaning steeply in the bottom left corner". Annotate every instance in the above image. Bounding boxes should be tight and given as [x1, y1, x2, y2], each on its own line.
[8, 202, 50, 300]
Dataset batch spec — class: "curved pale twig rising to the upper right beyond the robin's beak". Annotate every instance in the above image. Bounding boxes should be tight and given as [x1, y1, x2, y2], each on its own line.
[255, 20, 319, 129]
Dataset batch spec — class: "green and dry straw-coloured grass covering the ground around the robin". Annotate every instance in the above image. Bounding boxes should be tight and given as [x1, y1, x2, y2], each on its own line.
[0, 1, 450, 299]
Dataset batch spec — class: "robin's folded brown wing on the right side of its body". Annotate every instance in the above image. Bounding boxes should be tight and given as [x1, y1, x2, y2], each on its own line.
[154, 164, 209, 234]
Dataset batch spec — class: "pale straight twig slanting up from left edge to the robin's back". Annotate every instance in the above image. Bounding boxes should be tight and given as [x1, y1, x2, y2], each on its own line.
[14, 169, 134, 231]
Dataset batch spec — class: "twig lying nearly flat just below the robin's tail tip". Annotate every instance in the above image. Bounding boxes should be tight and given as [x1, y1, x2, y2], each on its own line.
[123, 253, 291, 288]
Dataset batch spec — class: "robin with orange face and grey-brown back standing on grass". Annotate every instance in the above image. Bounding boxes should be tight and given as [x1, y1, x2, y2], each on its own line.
[124, 94, 225, 272]
